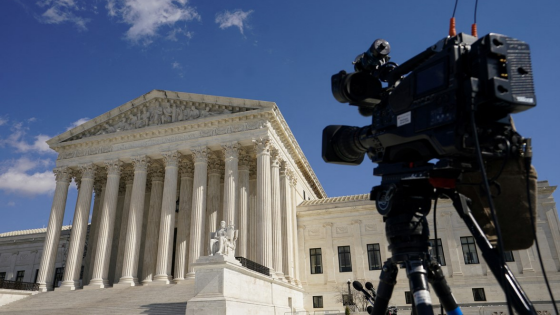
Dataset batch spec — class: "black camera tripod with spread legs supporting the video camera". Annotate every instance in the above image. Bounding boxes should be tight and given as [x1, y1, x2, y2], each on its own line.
[371, 163, 536, 315]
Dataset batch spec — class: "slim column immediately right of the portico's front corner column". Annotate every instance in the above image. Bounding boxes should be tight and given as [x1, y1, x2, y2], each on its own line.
[270, 149, 284, 279]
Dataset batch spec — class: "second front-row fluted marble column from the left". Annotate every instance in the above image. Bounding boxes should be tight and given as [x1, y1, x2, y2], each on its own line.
[59, 163, 97, 290]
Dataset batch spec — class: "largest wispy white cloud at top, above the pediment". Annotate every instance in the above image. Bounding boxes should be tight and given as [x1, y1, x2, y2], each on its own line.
[106, 0, 200, 45]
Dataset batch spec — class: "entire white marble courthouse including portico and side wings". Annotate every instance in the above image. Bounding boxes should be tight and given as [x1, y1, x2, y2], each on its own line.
[0, 90, 560, 314]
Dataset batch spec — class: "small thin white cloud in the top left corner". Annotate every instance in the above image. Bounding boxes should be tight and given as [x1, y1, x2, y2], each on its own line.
[37, 0, 90, 30]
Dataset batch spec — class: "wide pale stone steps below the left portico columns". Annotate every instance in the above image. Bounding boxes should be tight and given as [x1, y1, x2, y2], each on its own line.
[0, 281, 194, 315]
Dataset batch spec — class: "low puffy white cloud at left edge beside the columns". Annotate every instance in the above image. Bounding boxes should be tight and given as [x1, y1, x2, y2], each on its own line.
[0, 157, 56, 196]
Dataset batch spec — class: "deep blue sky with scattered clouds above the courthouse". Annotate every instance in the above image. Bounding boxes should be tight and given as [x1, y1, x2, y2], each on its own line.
[0, 0, 560, 233]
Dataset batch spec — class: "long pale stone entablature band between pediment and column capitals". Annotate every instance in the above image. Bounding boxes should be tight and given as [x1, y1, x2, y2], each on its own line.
[58, 120, 266, 160]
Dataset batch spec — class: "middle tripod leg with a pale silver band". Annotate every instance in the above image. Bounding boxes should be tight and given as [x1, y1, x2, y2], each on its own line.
[405, 259, 434, 315]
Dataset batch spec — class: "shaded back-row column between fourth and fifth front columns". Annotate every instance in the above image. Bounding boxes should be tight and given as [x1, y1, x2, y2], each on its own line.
[142, 163, 163, 285]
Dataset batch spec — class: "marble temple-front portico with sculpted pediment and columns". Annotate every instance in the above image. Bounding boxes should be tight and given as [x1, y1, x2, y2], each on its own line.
[37, 90, 325, 291]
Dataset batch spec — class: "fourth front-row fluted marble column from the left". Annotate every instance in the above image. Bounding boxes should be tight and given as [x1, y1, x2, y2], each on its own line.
[116, 155, 150, 287]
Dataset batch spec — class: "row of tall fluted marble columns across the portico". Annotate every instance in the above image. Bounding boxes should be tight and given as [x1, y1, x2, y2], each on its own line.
[37, 139, 299, 291]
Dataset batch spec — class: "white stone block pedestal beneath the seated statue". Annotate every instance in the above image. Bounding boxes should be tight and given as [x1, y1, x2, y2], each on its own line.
[186, 256, 304, 315]
